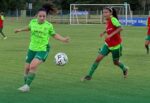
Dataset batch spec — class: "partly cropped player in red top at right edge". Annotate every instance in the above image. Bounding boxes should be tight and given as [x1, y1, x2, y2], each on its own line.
[145, 16, 150, 54]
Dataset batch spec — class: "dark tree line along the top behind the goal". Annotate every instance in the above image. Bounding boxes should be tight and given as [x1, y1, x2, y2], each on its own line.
[0, 0, 150, 11]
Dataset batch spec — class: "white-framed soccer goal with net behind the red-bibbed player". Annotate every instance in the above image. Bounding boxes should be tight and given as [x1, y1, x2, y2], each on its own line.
[70, 3, 132, 25]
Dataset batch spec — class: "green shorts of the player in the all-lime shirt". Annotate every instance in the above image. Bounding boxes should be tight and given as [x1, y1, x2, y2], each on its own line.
[26, 45, 50, 64]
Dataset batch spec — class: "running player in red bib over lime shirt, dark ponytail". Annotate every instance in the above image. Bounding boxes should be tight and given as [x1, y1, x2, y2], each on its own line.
[81, 7, 128, 81]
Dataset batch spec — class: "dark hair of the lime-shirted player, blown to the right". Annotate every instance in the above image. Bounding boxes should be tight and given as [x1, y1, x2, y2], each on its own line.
[38, 3, 57, 15]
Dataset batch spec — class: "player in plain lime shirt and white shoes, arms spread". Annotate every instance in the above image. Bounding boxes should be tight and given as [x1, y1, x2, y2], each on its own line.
[15, 5, 69, 92]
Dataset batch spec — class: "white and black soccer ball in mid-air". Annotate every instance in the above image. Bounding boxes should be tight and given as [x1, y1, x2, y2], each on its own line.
[55, 53, 68, 66]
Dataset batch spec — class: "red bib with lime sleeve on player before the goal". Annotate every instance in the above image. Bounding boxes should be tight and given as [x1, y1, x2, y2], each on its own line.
[105, 17, 122, 47]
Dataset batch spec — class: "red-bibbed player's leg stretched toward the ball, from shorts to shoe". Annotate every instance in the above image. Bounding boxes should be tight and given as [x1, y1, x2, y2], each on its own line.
[81, 44, 110, 81]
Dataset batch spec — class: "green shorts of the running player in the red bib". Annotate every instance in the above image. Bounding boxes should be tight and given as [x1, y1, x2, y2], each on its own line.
[99, 44, 122, 60]
